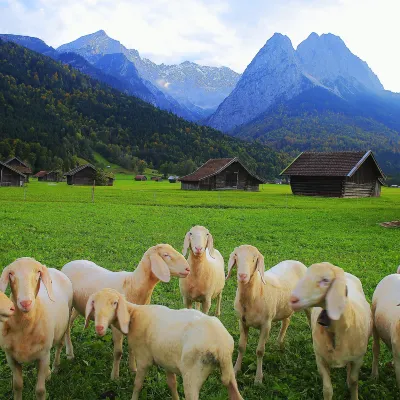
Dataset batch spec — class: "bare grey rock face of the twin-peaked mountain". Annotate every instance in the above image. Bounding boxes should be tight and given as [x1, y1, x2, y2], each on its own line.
[208, 33, 390, 132]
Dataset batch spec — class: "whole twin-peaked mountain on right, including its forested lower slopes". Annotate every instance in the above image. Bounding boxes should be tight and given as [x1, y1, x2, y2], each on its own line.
[207, 33, 400, 172]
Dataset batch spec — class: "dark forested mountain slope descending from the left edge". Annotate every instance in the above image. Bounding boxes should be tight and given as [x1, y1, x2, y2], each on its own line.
[0, 39, 286, 177]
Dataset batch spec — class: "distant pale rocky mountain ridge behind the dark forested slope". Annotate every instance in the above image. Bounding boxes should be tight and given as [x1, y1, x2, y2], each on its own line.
[58, 30, 240, 119]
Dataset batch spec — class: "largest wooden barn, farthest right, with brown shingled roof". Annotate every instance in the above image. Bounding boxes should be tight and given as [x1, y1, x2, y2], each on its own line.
[281, 150, 385, 197]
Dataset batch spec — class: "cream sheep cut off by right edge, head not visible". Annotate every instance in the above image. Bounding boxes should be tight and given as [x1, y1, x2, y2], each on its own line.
[372, 272, 400, 388]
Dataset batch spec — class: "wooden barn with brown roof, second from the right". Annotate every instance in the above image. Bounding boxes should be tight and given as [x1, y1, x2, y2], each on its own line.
[179, 157, 264, 191]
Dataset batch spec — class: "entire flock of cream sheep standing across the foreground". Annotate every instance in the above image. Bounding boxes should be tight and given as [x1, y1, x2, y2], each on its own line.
[0, 226, 400, 400]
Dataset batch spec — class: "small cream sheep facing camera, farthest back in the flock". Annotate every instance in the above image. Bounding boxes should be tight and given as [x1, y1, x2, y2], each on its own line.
[179, 226, 225, 317]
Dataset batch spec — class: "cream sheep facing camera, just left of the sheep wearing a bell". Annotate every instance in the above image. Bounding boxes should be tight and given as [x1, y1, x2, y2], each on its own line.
[226, 245, 310, 384]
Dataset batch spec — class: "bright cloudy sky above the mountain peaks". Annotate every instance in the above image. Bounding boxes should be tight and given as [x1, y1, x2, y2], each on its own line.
[0, 0, 400, 92]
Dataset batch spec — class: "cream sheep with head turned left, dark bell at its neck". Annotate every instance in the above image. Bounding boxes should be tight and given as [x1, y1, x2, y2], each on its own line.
[290, 262, 372, 400]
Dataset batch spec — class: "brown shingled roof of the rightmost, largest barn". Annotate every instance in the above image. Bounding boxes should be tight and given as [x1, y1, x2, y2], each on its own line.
[281, 150, 385, 178]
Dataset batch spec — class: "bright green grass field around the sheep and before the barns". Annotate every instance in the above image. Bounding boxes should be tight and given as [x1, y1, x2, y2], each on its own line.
[0, 180, 400, 400]
